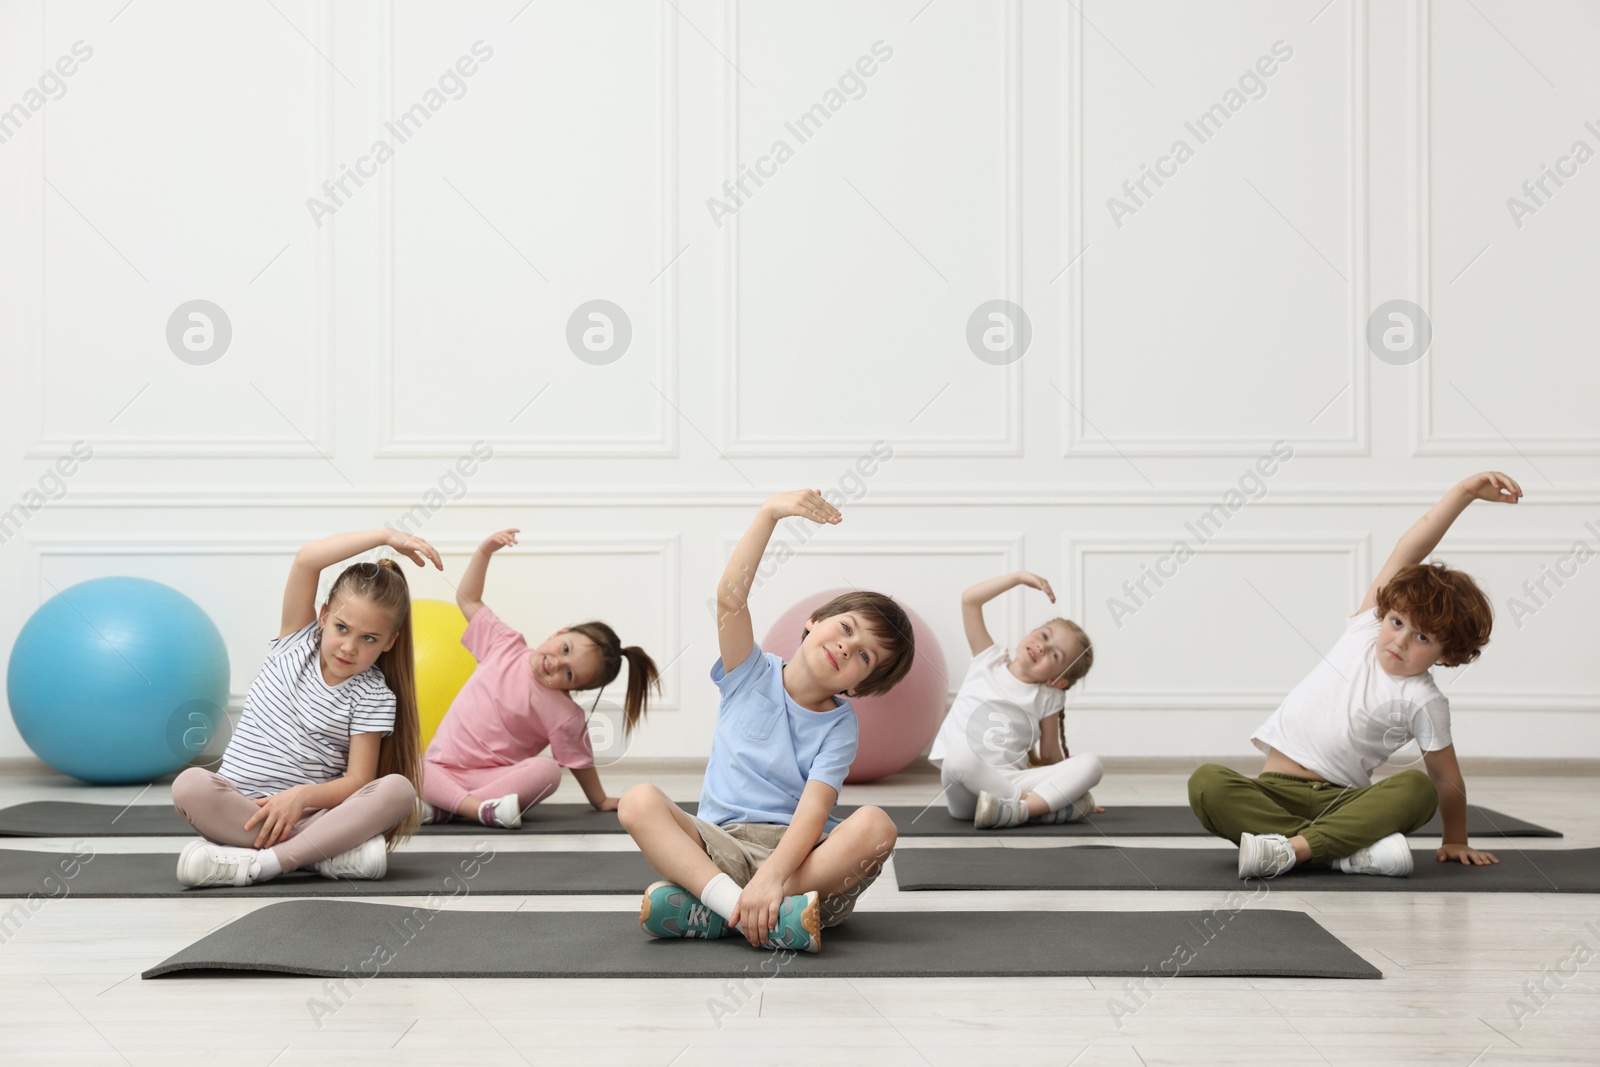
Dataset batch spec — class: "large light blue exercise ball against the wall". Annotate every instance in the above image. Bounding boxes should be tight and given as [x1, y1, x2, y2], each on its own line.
[6, 577, 229, 785]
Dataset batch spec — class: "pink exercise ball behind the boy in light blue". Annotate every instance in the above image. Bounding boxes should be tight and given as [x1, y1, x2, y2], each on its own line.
[762, 589, 949, 782]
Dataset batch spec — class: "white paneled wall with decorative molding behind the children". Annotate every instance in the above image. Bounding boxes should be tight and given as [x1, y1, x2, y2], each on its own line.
[0, 0, 1600, 767]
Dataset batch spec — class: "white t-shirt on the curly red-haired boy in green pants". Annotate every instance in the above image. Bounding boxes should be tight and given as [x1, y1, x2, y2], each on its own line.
[1251, 611, 1451, 785]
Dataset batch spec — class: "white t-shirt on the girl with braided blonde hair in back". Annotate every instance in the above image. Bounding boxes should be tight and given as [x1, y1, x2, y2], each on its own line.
[928, 645, 1067, 768]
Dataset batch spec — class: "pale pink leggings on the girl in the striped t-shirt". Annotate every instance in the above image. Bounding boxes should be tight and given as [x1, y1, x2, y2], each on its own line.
[173, 766, 416, 872]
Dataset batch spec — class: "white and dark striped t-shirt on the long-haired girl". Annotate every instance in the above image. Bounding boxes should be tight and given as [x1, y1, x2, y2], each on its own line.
[219, 621, 395, 797]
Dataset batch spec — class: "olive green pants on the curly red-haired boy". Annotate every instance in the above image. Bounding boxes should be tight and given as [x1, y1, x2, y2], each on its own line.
[1189, 763, 1438, 862]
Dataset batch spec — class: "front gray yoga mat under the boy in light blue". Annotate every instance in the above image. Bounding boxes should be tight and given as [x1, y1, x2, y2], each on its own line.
[144, 901, 1382, 979]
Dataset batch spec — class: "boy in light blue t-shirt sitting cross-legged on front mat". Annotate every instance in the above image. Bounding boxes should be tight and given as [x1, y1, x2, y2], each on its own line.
[616, 490, 915, 952]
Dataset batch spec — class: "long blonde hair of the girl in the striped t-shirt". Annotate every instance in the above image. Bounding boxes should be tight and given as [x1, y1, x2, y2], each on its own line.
[328, 560, 422, 849]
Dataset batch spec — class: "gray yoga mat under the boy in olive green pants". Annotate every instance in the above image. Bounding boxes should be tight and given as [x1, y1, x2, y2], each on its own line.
[894, 845, 1600, 893]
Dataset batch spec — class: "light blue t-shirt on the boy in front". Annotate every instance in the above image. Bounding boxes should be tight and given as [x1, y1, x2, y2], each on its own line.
[699, 645, 861, 830]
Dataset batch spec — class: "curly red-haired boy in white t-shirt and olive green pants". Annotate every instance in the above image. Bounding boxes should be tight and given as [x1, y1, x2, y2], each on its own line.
[1189, 470, 1522, 878]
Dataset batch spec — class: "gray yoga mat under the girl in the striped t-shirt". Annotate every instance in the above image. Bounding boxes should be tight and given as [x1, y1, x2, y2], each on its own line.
[0, 848, 659, 895]
